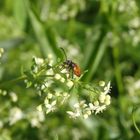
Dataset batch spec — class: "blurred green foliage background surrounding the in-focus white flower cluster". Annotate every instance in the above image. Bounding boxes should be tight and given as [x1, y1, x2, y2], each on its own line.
[0, 0, 140, 140]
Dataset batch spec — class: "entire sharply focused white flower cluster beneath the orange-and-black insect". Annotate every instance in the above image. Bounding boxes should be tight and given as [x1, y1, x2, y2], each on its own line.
[25, 55, 111, 119]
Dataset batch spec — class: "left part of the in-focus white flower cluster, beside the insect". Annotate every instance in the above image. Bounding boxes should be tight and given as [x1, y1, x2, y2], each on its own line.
[25, 55, 74, 114]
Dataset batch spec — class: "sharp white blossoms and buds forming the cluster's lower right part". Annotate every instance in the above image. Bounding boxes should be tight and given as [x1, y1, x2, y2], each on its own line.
[67, 81, 111, 119]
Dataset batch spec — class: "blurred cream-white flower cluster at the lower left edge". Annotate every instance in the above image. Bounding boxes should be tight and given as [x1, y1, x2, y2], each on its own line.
[0, 89, 45, 129]
